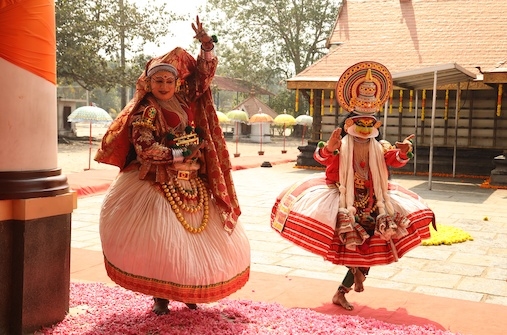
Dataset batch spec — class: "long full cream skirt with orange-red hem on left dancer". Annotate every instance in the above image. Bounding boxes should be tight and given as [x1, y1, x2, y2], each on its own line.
[100, 171, 250, 303]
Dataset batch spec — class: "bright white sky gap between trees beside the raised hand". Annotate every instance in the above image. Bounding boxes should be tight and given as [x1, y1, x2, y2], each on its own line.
[133, 0, 207, 56]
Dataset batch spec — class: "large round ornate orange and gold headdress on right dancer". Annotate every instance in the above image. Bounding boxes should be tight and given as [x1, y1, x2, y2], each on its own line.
[336, 61, 393, 116]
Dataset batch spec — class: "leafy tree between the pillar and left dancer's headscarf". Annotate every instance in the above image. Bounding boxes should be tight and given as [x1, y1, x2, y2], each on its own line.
[55, 0, 181, 106]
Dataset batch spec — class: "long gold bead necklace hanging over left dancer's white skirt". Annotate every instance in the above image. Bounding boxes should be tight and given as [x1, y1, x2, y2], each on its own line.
[161, 177, 209, 234]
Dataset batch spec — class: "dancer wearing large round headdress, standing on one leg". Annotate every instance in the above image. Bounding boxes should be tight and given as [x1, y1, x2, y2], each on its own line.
[271, 62, 435, 310]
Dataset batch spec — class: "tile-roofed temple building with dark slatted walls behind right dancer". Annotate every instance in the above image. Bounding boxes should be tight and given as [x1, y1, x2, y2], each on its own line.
[287, 0, 507, 175]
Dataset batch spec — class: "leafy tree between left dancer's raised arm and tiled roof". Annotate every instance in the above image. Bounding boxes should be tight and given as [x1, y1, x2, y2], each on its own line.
[203, 0, 341, 112]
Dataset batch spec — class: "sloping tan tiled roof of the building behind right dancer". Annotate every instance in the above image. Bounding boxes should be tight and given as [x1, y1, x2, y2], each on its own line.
[288, 0, 507, 88]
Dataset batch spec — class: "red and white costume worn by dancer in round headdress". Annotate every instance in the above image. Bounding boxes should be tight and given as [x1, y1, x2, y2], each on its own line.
[271, 135, 434, 267]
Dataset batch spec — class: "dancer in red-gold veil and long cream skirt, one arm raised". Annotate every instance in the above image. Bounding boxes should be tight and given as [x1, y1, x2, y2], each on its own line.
[95, 18, 250, 314]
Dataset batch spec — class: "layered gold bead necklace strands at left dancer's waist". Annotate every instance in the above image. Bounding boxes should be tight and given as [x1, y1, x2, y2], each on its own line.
[161, 177, 209, 234]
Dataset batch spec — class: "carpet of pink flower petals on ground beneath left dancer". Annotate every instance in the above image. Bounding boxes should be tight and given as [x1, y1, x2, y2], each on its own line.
[34, 283, 455, 335]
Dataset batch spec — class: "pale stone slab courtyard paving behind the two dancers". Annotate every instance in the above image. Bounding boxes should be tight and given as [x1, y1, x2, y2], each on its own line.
[72, 163, 507, 306]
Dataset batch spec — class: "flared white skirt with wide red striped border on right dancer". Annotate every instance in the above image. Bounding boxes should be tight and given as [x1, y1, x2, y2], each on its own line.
[271, 173, 435, 267]
